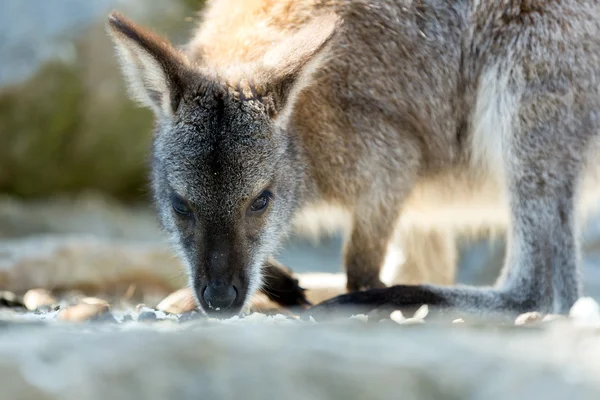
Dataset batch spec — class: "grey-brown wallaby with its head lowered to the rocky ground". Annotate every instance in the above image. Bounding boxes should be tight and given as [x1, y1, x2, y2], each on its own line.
[109, 0, 600, 315]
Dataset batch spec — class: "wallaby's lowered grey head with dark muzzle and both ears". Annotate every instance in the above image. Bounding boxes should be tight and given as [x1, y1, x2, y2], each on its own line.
[108, 13, 337, 313]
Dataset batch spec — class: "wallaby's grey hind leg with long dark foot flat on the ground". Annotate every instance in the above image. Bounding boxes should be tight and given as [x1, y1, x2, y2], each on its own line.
[310, 93, 598, 316]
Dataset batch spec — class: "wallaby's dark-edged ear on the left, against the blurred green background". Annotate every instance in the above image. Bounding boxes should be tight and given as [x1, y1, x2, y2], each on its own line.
[107, 12, 188, 118]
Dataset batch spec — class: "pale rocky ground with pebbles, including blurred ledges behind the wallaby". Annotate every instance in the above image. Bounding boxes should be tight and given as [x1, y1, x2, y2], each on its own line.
[0, 196, 600, 400]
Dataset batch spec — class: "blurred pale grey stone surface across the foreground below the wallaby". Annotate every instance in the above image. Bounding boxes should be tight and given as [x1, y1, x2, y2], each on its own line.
[0, 290, 600, 400]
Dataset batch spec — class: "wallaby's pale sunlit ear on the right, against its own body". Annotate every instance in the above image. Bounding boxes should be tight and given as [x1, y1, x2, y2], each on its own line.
[261, 13, 340, 115]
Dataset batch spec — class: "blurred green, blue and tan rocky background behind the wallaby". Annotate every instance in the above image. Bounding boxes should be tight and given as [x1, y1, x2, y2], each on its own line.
[0, 0, 600, 304]
